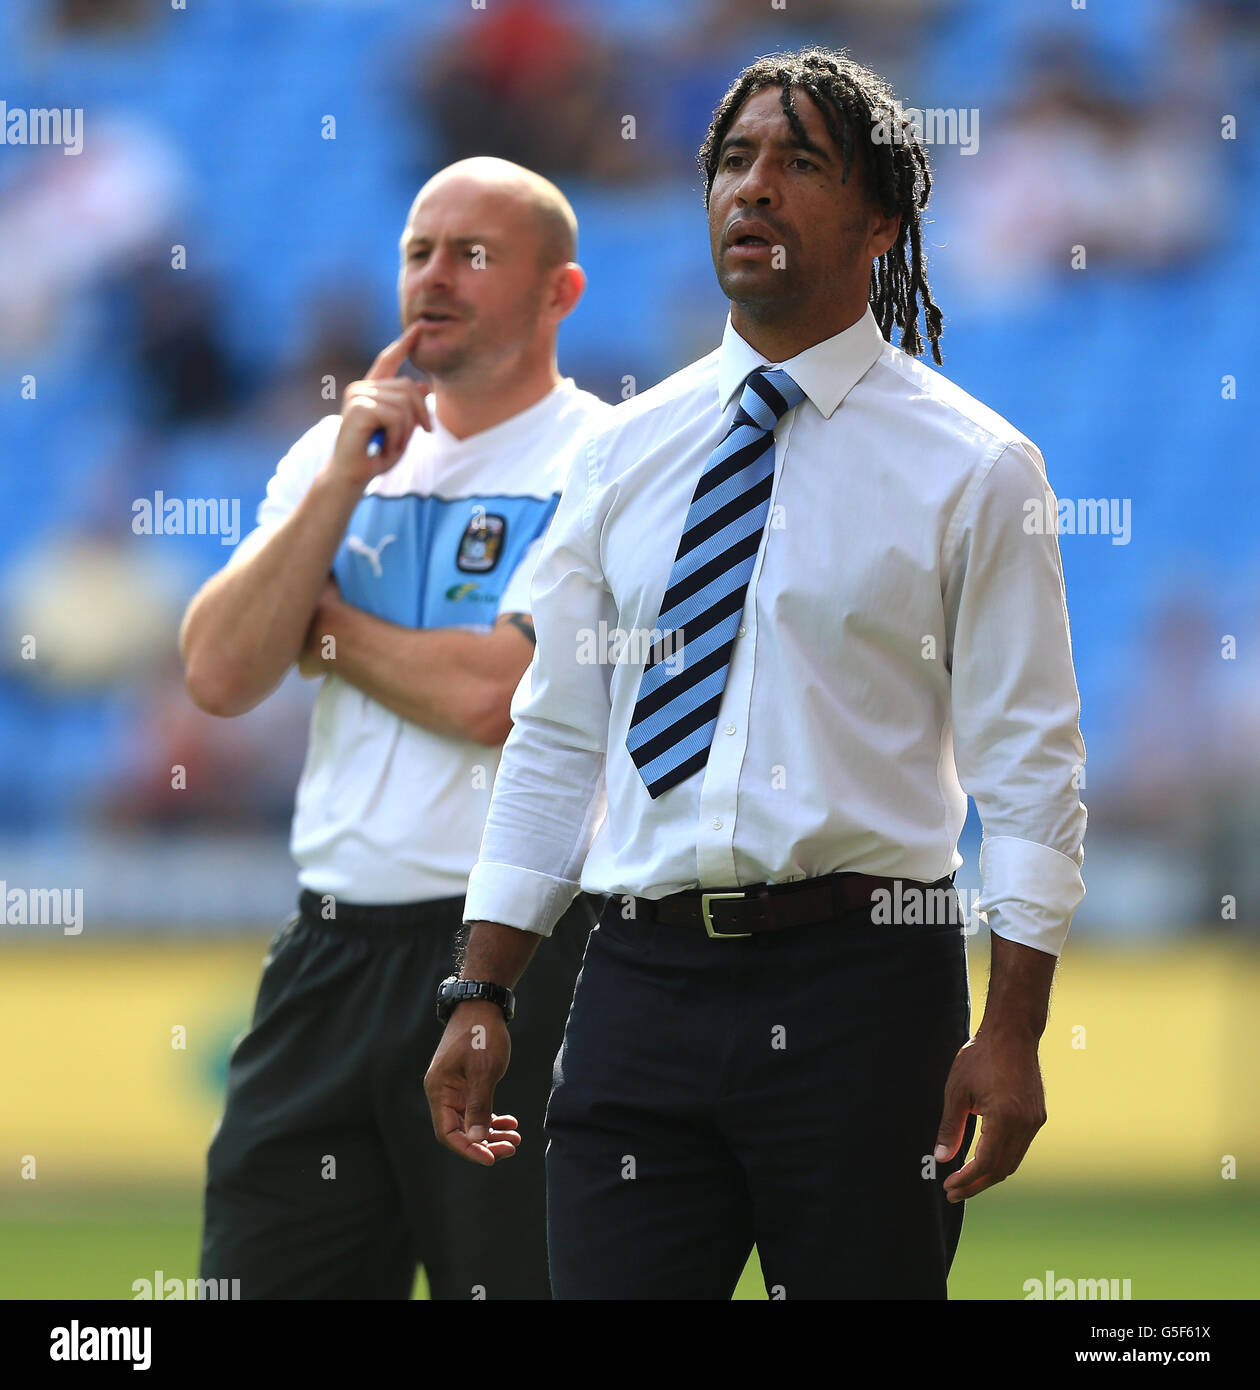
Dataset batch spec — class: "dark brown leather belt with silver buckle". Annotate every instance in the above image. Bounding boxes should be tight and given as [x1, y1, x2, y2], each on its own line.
[634, 873, 954, 938]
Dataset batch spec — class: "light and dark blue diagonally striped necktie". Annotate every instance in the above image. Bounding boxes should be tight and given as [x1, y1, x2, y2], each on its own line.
[626, 367, 805, 801]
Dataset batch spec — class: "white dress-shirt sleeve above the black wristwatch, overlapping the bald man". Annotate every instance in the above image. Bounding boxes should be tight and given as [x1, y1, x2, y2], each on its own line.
[463, 439, 616, 935]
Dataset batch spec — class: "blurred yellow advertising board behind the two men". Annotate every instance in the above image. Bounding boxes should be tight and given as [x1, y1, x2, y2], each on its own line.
[0, 938, 1260, 1201]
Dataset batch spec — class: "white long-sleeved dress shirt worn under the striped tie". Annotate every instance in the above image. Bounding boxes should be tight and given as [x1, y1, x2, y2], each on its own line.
[465, 309, 1085, 955]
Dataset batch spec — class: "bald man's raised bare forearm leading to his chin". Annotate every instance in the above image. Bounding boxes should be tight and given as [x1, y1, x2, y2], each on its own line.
[179, 470, 363, 716]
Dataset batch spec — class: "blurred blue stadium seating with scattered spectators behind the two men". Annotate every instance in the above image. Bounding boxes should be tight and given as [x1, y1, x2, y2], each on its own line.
[0, 0, 1260, 920]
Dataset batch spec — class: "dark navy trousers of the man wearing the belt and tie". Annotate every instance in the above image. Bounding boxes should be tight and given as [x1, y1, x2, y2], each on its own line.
[539, 888, 975, 1300]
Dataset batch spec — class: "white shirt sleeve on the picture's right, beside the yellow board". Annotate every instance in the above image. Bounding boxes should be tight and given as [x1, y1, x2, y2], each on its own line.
[946, 441, 1086, 955]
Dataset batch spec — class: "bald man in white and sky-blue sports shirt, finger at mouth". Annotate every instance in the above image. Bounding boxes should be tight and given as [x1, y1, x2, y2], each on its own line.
[181, 158, 609, 1298]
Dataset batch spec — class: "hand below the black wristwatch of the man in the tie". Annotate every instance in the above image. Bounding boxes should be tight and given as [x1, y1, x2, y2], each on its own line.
[424, 999, 520, 1166]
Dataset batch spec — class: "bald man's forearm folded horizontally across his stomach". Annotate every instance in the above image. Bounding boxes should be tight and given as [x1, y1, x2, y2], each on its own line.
[303, 602, 530, 745]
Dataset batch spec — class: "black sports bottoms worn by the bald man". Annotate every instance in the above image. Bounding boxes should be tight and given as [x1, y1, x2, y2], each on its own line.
[202, 892, 599, 1298]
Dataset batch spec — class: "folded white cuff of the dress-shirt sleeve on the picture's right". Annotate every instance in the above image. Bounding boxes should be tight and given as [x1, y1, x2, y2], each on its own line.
[976, 835, 1085, 956]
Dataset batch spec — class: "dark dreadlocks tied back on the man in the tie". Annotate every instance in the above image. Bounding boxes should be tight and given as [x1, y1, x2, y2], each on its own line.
[697, 47, 942, 364]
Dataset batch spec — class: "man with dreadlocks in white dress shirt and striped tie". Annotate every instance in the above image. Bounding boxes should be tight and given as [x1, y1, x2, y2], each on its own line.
[426, 50, 1085, 1298]
